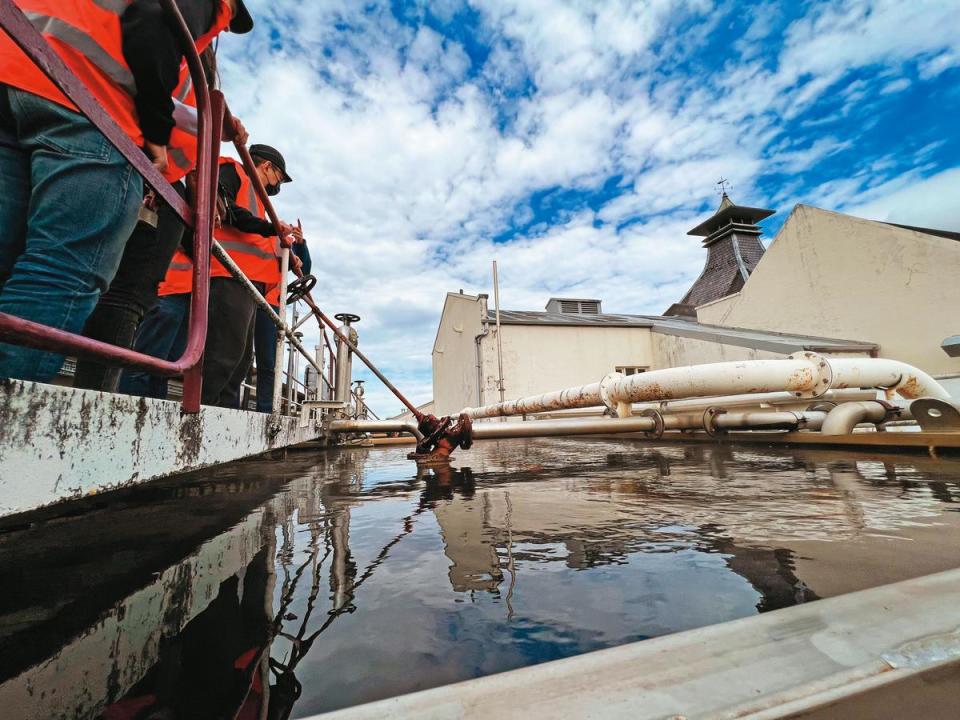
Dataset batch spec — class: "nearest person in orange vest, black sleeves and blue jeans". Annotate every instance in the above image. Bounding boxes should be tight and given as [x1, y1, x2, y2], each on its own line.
[0, 0, 252, 382]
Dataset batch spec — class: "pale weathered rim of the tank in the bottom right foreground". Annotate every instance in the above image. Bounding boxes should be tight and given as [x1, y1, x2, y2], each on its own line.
[314, 570, 960, 720]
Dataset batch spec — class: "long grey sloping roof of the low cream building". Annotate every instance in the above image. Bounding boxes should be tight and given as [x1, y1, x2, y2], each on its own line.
[500, 310, 879, 354]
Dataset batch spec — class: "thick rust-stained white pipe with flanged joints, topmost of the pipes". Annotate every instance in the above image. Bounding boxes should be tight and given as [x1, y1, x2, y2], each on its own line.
[462, 353, 949, 418]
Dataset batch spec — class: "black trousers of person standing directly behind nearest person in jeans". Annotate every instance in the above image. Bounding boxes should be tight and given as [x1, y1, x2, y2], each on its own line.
[73, 182, 186, 392]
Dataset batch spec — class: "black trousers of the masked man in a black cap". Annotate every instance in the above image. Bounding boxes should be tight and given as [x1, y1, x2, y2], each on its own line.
[200, 277, 264, 408]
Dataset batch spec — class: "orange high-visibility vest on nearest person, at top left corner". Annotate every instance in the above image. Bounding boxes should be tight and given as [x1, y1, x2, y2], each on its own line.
[0, 0, 143, 145]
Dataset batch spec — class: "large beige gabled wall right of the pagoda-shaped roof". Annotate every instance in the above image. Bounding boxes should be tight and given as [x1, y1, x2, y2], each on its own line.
[697, 205, 960, 375]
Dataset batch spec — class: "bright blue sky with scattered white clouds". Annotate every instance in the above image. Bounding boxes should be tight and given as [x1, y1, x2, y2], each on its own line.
[220, 0, 960, 415]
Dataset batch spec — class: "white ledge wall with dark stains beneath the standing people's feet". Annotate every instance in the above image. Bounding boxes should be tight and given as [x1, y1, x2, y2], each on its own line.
[0, 380, 322, 518]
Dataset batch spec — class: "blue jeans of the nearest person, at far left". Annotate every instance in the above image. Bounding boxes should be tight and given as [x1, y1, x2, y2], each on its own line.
[0, 85, 143, 382]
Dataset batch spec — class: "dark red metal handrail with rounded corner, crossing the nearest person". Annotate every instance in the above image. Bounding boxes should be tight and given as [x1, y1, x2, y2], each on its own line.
[0, 0, 217, 412]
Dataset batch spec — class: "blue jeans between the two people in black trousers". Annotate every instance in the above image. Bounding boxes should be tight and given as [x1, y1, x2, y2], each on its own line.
[118, 293, 190, 400]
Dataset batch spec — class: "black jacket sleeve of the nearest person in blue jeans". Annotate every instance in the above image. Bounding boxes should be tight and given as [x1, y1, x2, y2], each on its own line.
[120, 0, 219, 145]
